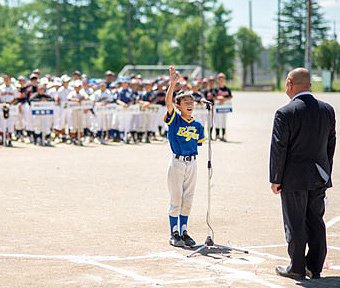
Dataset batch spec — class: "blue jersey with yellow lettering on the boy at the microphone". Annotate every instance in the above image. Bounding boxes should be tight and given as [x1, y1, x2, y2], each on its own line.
[164, 109, 205, 156]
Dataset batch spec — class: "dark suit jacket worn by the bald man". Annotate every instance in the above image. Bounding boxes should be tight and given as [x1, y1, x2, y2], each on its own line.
[270, 93, 336, 190]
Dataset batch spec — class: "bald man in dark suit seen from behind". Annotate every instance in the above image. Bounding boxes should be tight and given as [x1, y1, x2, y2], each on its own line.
[270, 68, 335, 279]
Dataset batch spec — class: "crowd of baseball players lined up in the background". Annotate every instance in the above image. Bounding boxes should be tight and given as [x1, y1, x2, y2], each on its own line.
[0, 71, 232, 146]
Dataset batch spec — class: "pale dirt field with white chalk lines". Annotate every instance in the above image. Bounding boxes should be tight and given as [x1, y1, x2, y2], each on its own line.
[0, 93, 340, 288]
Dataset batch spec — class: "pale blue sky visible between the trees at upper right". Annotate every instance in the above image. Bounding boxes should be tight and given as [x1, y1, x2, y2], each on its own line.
[220, 0, 340, 47]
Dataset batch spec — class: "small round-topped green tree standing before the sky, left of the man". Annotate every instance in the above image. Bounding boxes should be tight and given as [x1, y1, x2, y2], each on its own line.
[236, 27, 263, 86]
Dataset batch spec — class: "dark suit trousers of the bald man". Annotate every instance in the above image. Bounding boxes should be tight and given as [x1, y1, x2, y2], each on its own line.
[281, 183, 327, 275]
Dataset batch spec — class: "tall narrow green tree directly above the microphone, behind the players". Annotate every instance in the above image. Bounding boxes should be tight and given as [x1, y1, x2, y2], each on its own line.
[207, 5, 235, 78]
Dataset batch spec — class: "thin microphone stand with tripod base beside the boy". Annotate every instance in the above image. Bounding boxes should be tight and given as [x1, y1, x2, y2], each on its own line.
[187, 101, 249, 258]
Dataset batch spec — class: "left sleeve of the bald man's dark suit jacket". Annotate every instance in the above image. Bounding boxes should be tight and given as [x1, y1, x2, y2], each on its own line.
[269, 111, 289, 184]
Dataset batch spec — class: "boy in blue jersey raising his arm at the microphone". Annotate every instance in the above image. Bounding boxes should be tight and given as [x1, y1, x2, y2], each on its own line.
[164, 66, 205, 247]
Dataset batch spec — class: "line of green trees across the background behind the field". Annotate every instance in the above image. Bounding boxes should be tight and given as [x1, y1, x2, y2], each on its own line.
[0, 0, 340, 89]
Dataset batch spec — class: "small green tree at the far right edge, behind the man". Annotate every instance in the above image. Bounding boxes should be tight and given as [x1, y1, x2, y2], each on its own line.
[314, 39, 340, 89]
